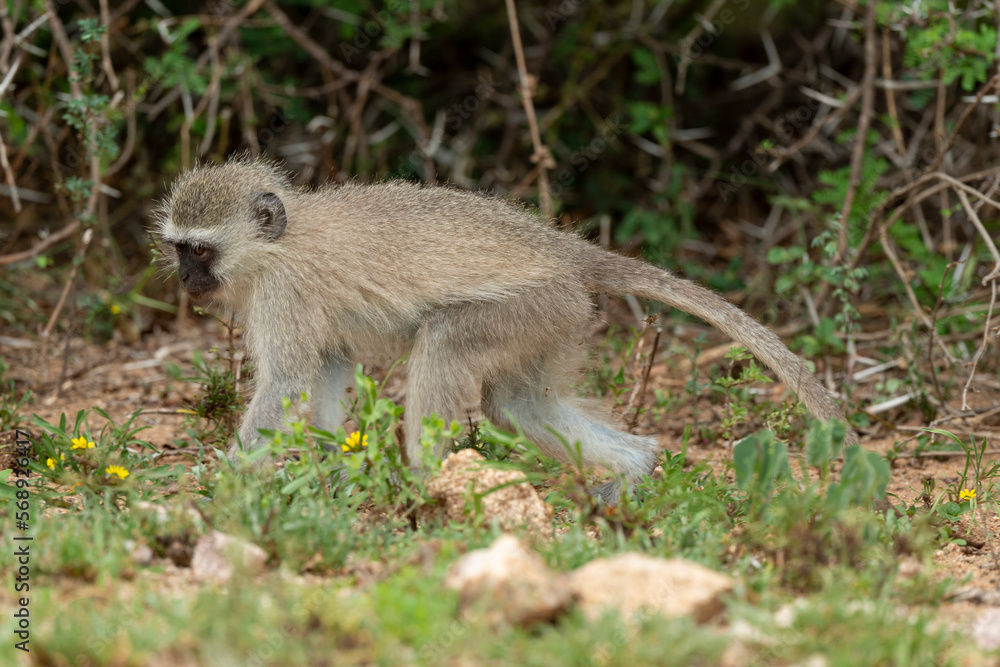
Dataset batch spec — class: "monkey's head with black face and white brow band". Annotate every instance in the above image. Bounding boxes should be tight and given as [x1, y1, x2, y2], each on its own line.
[152, 159, 290, 302]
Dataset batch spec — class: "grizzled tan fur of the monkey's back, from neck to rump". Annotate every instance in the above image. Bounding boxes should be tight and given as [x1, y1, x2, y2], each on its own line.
[286, 181, 589, 307]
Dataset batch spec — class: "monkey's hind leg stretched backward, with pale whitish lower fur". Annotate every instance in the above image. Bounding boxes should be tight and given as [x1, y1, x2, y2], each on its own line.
[483, 377, 659, 505]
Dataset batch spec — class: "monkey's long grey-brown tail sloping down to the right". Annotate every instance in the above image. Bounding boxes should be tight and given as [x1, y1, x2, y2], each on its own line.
[586, 252, 858, 445]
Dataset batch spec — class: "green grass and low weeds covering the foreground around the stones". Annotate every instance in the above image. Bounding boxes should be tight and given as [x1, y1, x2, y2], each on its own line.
[0, 374, 995, 667]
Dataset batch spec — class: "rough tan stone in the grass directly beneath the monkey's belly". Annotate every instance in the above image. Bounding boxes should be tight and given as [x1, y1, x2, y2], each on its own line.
[421, 449, 552, 537]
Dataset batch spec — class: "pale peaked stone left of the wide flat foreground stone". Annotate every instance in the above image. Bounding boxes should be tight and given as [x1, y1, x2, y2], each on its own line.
[444, 535, 573, 627]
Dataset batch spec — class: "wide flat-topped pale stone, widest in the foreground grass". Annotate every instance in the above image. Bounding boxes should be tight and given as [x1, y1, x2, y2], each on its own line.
[569, 553, 733, 623]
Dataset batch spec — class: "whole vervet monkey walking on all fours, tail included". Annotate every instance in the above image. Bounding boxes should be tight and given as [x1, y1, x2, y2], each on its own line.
[153, 159, 857, 503]
